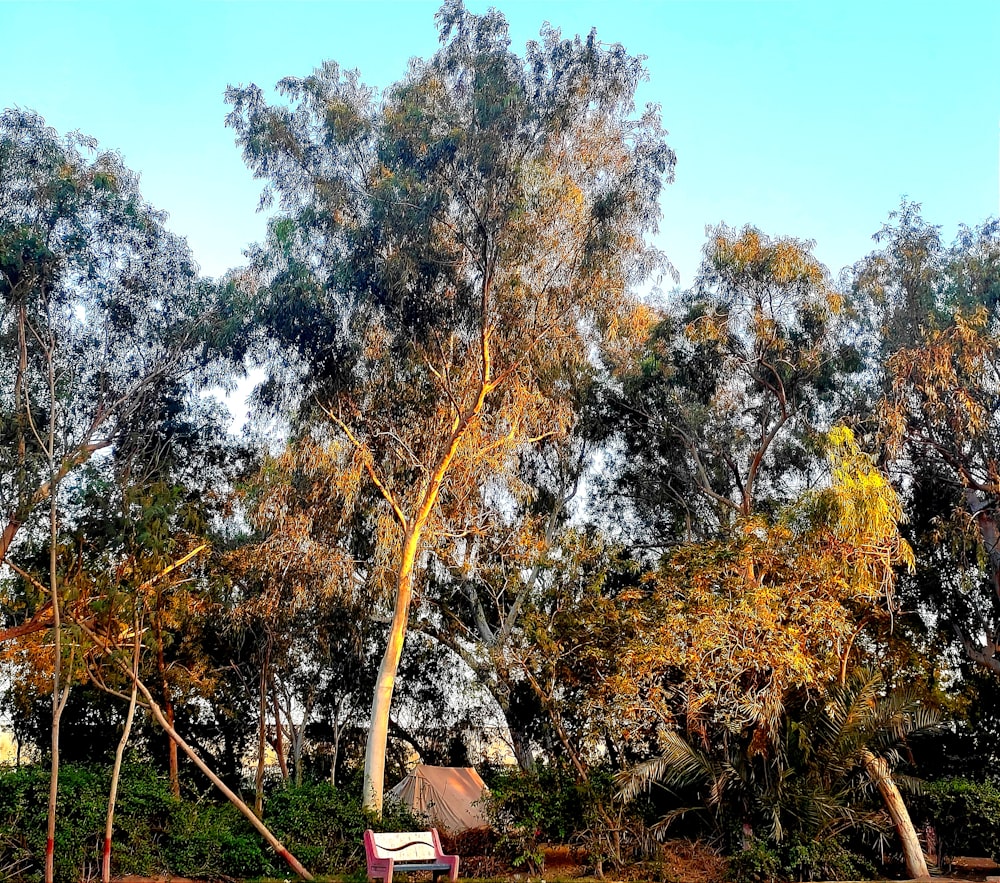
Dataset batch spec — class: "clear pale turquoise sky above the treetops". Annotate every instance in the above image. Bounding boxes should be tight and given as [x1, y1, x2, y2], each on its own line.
[0, 0, 1000, 285]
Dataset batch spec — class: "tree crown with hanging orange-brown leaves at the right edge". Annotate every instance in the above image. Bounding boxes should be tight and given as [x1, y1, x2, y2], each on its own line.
[851, 203, 1000, 673]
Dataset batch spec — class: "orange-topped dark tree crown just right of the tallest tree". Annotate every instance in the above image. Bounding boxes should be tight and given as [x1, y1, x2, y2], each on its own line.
[606, 226, 859, 550]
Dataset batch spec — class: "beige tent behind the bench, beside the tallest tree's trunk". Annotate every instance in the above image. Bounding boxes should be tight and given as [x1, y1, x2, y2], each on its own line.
[392, 764, 489, 833]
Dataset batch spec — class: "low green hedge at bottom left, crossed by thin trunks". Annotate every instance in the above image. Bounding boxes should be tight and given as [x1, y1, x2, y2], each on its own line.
[0, 764, 427, 883]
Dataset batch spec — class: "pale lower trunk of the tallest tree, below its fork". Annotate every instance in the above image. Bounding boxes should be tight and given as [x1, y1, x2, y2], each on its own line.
[362, 530, 419, 817]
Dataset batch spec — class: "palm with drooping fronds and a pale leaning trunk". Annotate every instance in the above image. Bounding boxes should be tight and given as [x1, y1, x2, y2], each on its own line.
[617, 668, 938, 877]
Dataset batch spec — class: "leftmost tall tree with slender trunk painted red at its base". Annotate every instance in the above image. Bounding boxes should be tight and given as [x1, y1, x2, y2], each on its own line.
[0, 110, 220, 881]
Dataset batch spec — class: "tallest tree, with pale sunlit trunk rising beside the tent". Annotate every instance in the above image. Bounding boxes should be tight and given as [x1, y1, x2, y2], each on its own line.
[228, 0, 674, 811]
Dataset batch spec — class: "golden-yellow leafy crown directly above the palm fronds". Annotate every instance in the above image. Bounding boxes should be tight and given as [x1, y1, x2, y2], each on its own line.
[619, 427, 913, 735]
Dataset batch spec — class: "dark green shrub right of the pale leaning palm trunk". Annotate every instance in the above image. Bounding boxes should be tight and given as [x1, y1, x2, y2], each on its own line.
[912, 777, 1000, 859]
